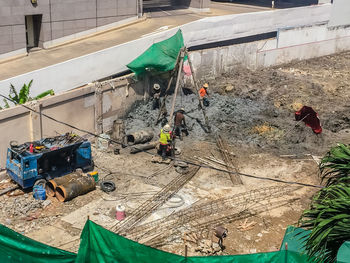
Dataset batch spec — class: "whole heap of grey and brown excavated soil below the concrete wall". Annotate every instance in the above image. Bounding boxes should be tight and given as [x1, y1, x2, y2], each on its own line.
[126, 52, 350, 157]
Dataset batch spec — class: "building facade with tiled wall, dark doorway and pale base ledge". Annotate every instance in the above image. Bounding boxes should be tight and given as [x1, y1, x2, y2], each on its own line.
[0, 0, 210, 59]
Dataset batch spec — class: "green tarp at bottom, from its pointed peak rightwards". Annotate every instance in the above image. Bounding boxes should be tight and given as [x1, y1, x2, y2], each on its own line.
[76, 221, 308, 263]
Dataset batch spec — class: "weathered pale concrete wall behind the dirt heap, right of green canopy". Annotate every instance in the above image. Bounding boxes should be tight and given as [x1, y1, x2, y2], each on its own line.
[190, 24, 350, 79]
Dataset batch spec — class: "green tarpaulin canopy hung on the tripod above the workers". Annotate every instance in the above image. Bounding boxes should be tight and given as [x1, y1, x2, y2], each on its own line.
[127, 29, 184, 75]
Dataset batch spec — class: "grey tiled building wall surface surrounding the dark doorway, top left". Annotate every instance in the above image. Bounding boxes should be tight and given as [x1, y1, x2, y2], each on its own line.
[0, 0, 138, 55]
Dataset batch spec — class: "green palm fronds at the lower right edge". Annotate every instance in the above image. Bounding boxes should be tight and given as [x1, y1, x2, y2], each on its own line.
[299, 183, 350, 262]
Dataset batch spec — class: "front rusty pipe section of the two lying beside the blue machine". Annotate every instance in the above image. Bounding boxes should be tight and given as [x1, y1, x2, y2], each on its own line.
[56, 176, 96, 202]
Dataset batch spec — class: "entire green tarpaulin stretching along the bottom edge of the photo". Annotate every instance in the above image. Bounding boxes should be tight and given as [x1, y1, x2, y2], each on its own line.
[0, 220, 350, 263]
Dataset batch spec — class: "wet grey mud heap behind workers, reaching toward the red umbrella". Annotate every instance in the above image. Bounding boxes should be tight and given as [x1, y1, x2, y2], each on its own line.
[126, 93, 323, 156]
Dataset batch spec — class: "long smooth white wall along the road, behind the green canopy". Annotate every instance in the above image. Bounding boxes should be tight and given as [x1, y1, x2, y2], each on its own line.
[0, 4, 332, 95]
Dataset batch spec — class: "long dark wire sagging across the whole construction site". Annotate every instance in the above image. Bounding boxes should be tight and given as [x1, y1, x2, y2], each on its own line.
[0, 94, 324, 188]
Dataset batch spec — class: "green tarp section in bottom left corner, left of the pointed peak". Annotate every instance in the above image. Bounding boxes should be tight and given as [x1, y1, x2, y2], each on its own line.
[0, 225, 77, 263]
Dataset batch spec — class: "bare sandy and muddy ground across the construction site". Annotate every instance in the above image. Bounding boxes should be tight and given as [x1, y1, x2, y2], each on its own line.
[0, 52, 350, 255]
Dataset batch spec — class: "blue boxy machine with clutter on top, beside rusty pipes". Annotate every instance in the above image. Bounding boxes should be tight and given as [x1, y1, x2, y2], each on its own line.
[6, 133, 93, 189]
